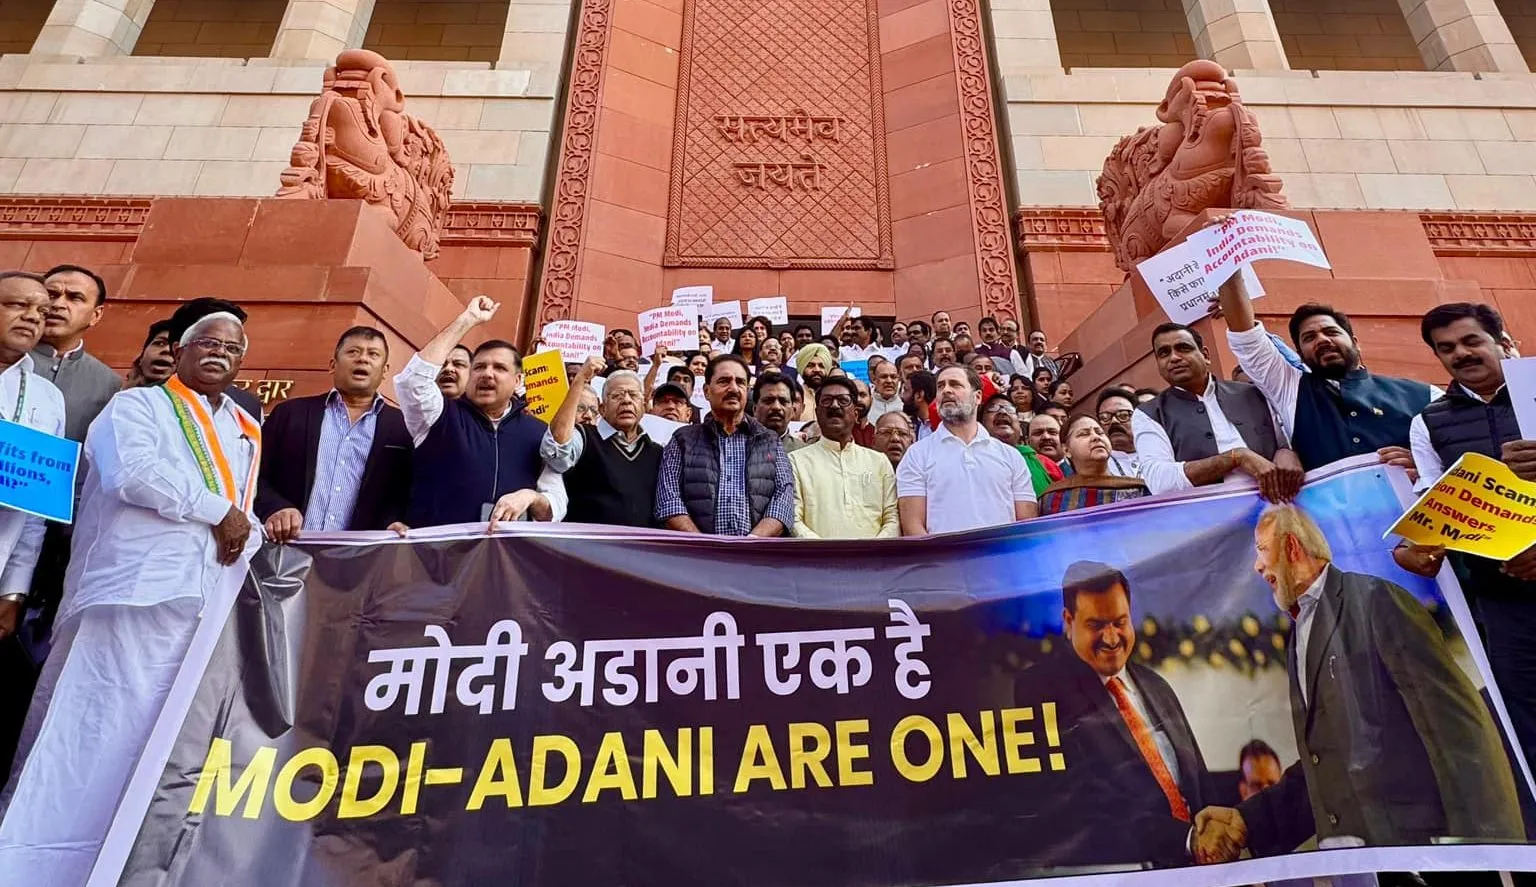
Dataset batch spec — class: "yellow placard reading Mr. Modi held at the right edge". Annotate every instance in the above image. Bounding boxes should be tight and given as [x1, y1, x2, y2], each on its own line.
[1387, 453, 1536, 561]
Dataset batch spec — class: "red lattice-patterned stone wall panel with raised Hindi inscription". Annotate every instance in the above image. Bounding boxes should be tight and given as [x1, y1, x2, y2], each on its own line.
[662, 0, 895, 271]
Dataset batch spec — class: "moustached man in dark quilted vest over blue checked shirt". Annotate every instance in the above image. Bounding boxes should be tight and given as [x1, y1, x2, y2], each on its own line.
[656, 354, 794, 537]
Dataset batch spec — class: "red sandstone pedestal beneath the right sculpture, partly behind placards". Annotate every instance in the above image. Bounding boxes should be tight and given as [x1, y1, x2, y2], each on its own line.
[1061, 211, 1486, 403]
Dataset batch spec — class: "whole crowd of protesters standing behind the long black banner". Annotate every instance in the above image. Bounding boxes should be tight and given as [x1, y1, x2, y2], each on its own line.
[0, 225, 1536, 865]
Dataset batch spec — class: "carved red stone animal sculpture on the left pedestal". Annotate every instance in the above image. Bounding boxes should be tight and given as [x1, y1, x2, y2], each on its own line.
[276, 49, 453, 258]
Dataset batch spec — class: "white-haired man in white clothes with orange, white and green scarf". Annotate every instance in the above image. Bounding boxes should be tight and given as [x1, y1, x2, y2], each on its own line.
[0, 315, 261, 887]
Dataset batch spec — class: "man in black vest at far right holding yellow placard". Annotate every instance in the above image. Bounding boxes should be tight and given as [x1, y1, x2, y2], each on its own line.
[1393, 301, 1536, 761]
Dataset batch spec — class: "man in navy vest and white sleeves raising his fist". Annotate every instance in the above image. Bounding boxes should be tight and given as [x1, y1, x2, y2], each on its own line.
[395, 295, 567, 532]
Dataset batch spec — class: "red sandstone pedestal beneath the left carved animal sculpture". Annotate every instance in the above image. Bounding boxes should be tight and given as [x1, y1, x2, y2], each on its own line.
[76, 198, 497, 404]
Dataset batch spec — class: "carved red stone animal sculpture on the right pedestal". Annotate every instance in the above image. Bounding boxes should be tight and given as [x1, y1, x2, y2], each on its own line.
[1098, 60, 1290, 272]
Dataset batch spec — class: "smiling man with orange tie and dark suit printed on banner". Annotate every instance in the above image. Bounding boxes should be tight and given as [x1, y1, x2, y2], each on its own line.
[1015, 561, 1210, 865]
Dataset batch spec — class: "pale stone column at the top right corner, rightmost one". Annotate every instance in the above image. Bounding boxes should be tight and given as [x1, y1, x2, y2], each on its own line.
[1398, 0, 1530, 74]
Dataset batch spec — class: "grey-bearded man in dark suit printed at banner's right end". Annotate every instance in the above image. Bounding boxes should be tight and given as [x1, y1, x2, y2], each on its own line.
[1198, 506, 1525, 856]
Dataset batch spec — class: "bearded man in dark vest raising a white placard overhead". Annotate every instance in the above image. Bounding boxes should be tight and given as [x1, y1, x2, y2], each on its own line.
[1221, 274, 1442, 470]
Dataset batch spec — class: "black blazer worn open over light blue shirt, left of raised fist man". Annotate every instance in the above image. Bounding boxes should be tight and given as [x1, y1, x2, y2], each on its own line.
[257, 394, 415, 530]
